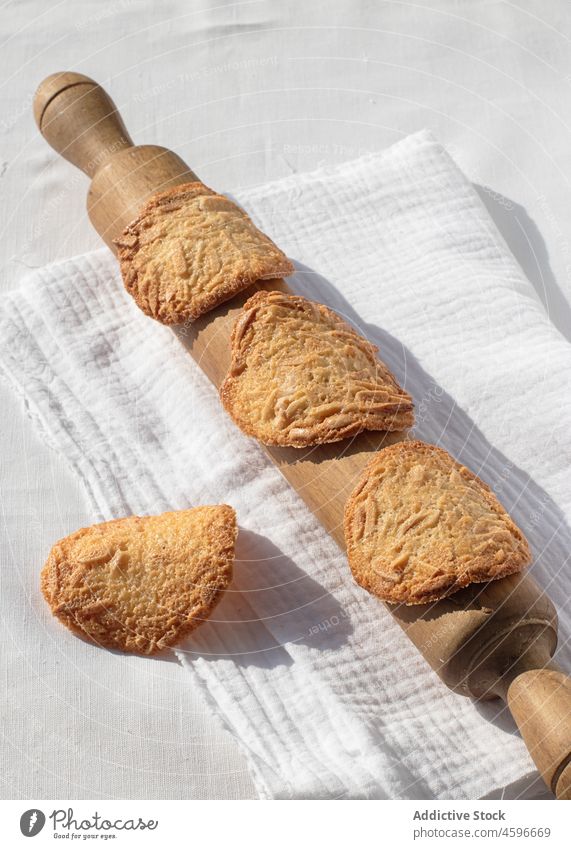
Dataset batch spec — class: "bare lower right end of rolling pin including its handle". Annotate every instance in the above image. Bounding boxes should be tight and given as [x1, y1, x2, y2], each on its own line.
[393, 573, 571, 799]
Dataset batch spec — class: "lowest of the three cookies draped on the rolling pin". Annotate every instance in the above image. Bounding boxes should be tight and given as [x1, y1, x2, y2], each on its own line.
[345, 441, 531, 604]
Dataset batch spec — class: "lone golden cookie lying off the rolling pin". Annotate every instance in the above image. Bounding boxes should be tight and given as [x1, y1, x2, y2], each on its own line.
[41, 504, 237, 654]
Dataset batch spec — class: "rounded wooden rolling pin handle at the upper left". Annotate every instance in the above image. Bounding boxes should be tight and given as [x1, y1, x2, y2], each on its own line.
[34, 71, 133, 177]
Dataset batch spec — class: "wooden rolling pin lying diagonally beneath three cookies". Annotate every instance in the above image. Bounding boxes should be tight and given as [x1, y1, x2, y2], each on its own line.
[34, 72, 571, 799]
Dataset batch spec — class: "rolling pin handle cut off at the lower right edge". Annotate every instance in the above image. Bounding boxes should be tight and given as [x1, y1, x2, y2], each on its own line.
[504, 663, 571, 799]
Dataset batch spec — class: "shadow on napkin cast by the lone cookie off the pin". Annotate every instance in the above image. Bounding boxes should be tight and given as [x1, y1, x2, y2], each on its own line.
[172, 528, 353, 669]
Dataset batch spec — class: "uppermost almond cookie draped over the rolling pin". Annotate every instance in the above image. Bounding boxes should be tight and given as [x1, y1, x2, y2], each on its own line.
[115, 183, 294, 324]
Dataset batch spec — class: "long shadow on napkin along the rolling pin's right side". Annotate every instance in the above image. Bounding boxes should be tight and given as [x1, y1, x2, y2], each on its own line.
[292, 263, 571, 672]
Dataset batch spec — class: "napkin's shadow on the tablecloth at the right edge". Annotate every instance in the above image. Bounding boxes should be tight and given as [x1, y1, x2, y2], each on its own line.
[473, 183, 571, 342]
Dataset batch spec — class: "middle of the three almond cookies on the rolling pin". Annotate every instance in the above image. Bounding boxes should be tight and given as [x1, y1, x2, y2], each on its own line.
[220, 291, 414, 448]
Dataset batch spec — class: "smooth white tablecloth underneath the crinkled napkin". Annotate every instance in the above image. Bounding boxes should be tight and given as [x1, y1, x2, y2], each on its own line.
[0, 0, 571, 799]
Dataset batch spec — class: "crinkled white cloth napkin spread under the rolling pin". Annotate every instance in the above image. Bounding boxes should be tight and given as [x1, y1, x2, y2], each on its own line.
[0, 132, 571, 798]
